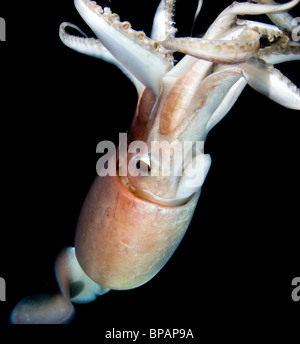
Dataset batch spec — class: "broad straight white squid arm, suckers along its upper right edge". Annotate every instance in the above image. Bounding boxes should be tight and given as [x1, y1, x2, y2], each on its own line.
[75, 0, 172, 94]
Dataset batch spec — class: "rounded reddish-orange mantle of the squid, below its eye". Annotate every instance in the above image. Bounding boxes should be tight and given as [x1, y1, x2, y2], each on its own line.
[75, 172, 199, 290]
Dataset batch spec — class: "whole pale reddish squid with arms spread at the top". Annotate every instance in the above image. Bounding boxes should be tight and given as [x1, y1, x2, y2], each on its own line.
[10, 0, 300, 324]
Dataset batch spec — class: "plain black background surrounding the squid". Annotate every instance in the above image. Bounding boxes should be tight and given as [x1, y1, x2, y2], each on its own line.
[0, 0, 300, 343]
